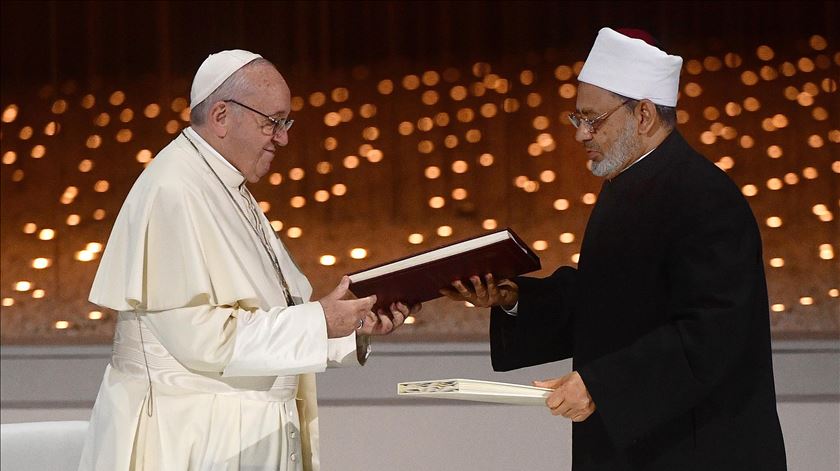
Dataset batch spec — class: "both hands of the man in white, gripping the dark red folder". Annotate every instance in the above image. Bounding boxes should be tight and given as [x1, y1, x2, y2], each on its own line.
[318, 276, 420, 338]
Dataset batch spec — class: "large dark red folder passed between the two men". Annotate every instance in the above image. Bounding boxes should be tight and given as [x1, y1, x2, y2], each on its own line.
[349, 229, 540, 310]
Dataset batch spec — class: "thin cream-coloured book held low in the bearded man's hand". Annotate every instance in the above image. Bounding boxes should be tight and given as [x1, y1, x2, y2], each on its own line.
[397, 379, 552, 406]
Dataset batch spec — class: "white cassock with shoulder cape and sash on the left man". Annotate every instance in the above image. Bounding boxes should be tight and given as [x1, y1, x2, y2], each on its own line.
[79, 129, 367, 471]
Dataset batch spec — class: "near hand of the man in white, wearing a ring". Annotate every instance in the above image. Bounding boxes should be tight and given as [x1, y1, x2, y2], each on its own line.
[318, 276, 376, 339]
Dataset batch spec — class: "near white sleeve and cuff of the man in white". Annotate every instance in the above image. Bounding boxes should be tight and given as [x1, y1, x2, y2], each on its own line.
[143, 302, 338, 376]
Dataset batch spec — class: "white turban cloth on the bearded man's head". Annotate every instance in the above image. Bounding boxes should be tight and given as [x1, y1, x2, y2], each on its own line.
[578, 28, 682, 107]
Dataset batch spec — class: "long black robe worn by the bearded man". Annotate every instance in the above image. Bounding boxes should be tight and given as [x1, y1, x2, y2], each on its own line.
[490, 131, 786, 471]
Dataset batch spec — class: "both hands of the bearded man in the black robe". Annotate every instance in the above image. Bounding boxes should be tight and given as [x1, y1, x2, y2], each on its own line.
[441, 273, 595, 422]
